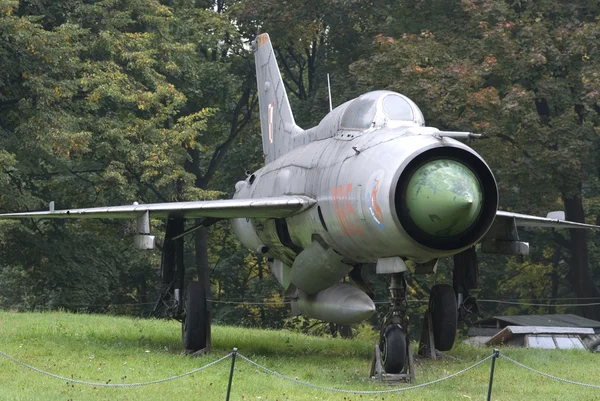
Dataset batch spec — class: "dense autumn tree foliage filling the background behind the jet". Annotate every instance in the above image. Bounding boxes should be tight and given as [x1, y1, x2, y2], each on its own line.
[0, 0, 600, 327]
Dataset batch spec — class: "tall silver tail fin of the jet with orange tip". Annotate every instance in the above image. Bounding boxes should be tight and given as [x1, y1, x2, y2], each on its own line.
[253, 33, 303, 163]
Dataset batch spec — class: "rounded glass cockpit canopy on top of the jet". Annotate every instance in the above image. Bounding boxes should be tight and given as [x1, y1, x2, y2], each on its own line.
[340, 91, 425, 130]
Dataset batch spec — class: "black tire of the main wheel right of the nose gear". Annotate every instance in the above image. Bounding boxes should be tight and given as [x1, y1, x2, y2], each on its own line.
[429, 284, 458, 351]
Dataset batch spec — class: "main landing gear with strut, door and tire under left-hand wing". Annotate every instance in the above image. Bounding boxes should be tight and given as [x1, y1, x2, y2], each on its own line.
[153, 217, 212, 352]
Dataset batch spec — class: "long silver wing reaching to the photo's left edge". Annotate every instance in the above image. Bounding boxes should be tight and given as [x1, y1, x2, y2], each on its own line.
[0, 195, 316, 219]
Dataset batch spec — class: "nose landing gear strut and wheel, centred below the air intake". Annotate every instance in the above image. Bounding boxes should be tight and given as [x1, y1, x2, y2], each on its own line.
[379, 273, 409, 374]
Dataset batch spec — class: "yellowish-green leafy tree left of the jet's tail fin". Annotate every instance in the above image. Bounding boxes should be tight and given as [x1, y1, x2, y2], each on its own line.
[0, 1, 241, 310]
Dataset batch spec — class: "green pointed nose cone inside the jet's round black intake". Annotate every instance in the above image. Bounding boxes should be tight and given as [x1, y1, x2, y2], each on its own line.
[405, 159, 483, 237]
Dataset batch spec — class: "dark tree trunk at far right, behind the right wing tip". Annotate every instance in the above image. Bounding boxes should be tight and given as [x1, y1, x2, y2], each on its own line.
[563, 192, 600, 320]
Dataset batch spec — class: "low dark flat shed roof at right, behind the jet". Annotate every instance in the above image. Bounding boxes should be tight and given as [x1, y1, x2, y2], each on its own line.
[475, 314, 600, 329]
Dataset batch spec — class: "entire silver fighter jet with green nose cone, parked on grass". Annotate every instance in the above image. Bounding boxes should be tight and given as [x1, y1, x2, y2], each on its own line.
[0, 34, 598, 373]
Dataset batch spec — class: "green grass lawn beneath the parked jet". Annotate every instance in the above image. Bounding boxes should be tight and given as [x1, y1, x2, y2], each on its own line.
[0, 312, 600, 401]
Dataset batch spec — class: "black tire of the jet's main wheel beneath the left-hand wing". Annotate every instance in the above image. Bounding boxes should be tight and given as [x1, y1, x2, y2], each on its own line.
[181, 281, 208, 351]
